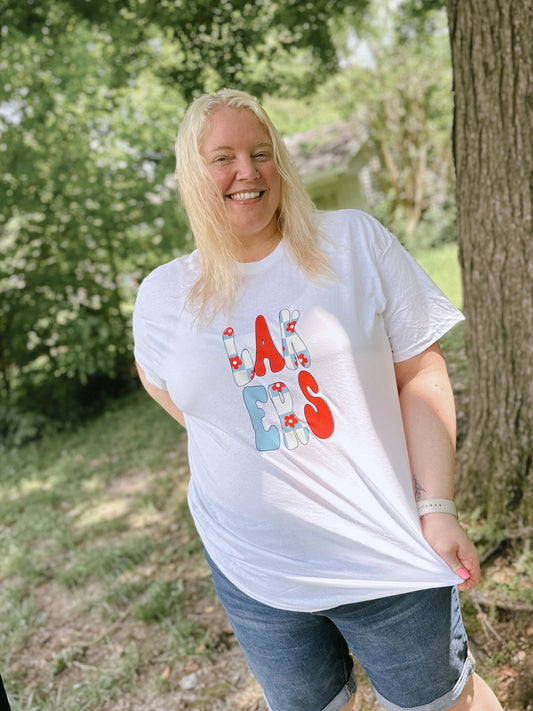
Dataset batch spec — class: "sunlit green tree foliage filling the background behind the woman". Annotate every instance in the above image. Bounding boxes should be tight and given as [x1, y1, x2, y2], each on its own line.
[0, 0, 452, 446]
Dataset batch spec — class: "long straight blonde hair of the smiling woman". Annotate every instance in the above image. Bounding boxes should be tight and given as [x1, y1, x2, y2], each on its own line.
[176, 89, 329, 316]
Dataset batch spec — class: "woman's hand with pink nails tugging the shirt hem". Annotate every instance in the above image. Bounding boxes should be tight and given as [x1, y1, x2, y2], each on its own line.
[420, 513, 481, 590]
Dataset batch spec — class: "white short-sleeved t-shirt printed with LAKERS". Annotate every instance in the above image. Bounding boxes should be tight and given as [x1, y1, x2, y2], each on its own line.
[134, 210, 462, 611]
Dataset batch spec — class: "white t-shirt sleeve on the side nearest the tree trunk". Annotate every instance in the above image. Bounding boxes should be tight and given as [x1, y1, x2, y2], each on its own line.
[377, 227, 464, 362]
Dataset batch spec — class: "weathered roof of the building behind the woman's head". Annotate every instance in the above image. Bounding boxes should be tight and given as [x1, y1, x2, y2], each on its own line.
[285, 120, 368, 182]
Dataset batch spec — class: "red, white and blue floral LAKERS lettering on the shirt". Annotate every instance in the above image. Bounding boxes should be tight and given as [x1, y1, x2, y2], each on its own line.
[222, 309, 335, 452]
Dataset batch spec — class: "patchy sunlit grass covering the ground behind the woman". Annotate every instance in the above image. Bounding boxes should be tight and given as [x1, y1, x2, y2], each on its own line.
[0, 246, 533, 711]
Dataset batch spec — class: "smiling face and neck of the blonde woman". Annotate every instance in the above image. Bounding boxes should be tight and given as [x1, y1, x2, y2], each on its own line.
[200, 107, 281, 261]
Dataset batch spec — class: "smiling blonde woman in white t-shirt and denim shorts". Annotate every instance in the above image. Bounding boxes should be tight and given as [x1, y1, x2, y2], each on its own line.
[134, 90, 501, 711]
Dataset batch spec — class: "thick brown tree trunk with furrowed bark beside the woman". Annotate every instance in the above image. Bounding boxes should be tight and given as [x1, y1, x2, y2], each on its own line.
[447, 0, 533, 526]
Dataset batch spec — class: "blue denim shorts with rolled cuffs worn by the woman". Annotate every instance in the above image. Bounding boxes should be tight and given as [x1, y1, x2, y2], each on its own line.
[206, 555, 474, 711]
